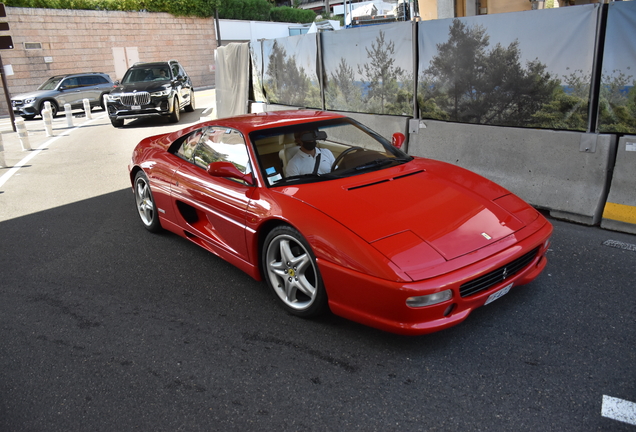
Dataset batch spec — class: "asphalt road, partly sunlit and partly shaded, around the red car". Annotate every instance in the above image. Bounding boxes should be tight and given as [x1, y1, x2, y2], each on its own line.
[0, 94, 636, 432]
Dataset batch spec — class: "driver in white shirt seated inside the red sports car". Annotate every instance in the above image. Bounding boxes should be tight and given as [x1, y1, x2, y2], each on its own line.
[285, 131, 335, 177]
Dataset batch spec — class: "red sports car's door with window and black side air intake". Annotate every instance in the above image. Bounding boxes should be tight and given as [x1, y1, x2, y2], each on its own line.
[172, 126, 256, 261]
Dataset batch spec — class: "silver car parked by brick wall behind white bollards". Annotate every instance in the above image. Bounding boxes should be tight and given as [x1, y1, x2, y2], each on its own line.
[11, 72, 113, 119]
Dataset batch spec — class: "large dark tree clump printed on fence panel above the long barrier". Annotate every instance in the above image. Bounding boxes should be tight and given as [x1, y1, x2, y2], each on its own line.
[418, 20, 560, 126]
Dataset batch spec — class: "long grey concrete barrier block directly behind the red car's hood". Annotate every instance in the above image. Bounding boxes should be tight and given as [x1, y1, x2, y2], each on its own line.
[409, 120, 620, 225]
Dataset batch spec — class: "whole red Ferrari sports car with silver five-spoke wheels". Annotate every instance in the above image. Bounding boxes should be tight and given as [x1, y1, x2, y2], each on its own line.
[129, 110, 552, 335]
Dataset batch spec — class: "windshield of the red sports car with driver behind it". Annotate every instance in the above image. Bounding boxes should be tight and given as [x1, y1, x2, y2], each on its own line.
[250, 118, 412, 186]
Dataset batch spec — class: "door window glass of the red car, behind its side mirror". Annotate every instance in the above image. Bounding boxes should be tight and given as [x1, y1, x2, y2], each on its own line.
[194, 126, 252, 179]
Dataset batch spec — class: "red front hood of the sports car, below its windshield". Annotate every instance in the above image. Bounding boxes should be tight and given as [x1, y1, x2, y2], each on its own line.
[276, 165, 525, 260]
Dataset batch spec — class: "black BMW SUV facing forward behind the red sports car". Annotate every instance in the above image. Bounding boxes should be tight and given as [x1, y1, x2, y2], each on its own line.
[106, 60, 194, 127]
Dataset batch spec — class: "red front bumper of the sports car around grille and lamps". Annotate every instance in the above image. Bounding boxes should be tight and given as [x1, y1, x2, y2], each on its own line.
[318, 221, 552, 335]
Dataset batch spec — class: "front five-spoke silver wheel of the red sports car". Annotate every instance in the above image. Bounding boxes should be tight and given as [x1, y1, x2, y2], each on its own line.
[262, 225, 327, 317]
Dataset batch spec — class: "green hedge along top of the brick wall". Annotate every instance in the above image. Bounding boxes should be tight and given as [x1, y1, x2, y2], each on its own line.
[4, 0, 316, 23]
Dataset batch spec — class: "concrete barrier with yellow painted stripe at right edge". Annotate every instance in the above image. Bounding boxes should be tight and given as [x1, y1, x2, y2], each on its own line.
[601, 135, 636, 234]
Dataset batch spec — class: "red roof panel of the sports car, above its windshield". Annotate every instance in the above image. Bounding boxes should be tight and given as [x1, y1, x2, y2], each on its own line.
[207, 110, 347, 133]
